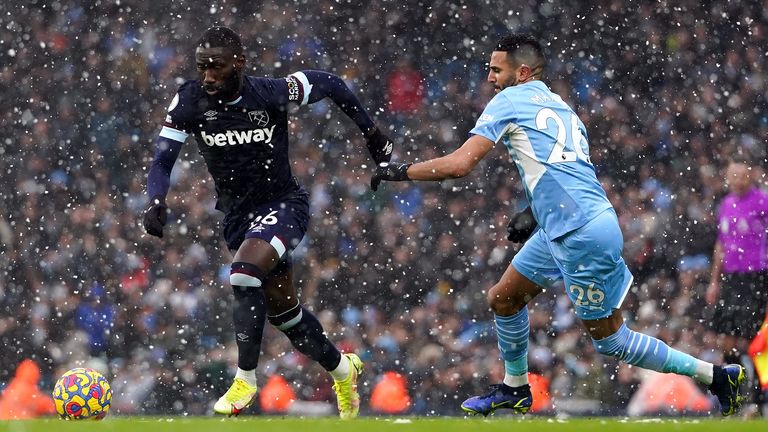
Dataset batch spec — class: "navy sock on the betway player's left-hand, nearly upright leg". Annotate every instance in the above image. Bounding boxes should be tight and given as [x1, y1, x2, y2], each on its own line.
[232, 285, 267, 370]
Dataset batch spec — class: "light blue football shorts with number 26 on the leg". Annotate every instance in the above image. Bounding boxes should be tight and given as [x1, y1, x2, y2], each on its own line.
[512, 209, 632, 320]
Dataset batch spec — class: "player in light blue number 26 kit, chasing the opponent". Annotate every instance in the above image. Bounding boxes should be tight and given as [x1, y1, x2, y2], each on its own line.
[371, 33, 745, 416]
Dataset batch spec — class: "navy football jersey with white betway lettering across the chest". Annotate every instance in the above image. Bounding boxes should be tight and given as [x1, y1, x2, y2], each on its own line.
[160, 72, 311, 214]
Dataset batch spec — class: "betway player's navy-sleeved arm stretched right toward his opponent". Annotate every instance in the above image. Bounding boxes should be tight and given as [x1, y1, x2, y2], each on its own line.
[300, 70, 393, 164]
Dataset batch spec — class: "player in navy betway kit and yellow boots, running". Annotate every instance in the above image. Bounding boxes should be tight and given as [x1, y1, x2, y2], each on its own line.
[144, 27, 392, 418]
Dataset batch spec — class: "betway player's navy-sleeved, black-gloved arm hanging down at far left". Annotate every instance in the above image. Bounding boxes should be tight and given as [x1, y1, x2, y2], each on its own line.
[144, 137, 183, 238]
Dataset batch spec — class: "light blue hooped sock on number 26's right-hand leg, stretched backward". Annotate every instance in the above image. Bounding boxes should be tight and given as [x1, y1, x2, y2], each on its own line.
[592, 324, 711, 382]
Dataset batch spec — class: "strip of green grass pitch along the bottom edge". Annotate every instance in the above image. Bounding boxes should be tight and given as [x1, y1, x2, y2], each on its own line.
[0, 416, 768, 432]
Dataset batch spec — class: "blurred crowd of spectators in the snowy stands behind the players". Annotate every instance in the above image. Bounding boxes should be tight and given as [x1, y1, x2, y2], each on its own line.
[0, 0, 768, 415]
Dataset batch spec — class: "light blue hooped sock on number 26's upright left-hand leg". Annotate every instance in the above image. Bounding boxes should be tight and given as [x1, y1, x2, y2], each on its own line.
[493, 306, 531, 377]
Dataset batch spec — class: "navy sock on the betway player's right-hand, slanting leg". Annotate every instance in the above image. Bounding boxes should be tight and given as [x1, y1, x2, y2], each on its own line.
[268, 304, 341, 372]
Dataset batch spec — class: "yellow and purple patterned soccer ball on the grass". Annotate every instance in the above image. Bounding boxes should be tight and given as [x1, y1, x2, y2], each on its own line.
[53, 368, 112, 420]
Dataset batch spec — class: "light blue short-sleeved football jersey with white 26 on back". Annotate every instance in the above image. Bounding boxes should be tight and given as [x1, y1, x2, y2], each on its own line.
[470, 80, 611, 239]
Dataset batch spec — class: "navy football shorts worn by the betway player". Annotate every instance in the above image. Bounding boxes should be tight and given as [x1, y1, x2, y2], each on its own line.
[223, 191, 309, 260]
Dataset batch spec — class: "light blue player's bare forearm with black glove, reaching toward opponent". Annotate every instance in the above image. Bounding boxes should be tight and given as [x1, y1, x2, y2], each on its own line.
[371, 135, 493, 191]
